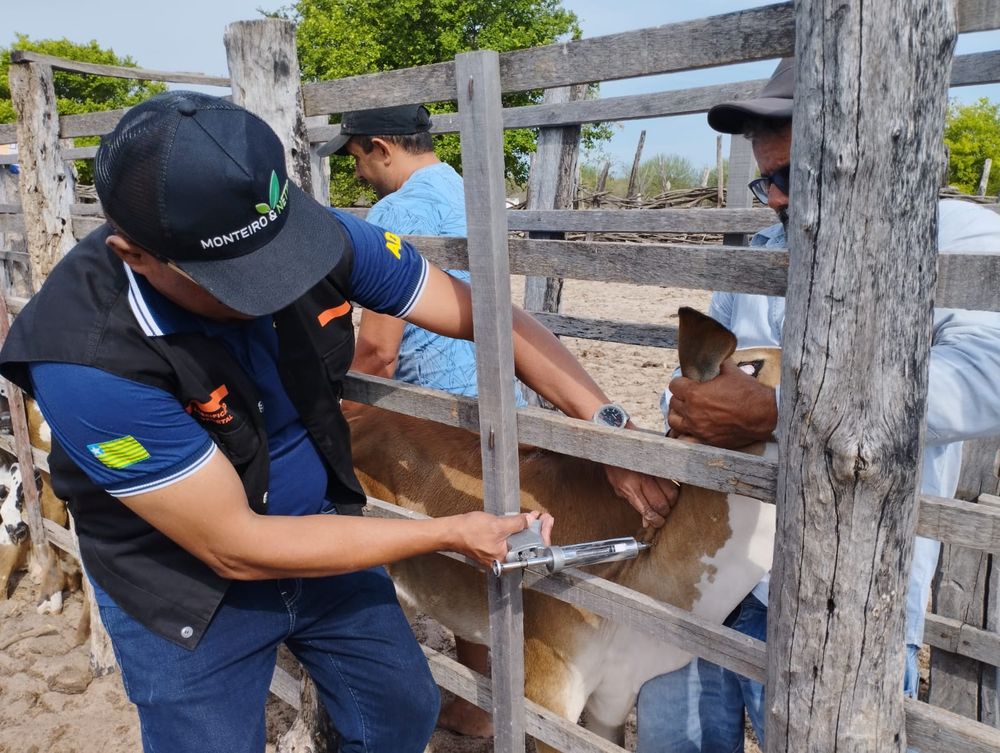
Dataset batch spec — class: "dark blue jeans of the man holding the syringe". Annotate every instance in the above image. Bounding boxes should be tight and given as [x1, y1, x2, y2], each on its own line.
[98, 568, 440, 753]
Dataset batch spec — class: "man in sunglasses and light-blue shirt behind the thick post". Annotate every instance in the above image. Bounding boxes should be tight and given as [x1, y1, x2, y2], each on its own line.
[637, 58, 1000, 753]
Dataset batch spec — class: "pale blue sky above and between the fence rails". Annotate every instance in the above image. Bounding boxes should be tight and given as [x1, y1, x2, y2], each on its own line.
[0, 0, 1000, 173]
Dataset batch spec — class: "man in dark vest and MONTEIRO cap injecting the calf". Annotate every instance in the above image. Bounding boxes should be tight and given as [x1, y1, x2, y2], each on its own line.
[0, 92, 671, 753]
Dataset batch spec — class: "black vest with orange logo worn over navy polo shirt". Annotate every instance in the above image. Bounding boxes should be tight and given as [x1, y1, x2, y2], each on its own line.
[0, 225, 365, 648]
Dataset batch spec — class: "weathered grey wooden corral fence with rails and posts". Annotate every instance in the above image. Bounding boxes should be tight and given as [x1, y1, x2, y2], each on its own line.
[0, 0, 1000, 753]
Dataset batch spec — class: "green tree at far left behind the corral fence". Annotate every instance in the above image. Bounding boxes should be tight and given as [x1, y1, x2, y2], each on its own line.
[0, 34, 166, 183]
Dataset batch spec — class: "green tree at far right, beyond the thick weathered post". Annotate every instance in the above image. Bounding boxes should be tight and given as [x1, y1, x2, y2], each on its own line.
[944, 97, 1000, 194]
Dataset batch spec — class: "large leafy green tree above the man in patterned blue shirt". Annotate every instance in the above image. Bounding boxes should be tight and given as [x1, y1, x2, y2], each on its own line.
[272, 0, 584, 204]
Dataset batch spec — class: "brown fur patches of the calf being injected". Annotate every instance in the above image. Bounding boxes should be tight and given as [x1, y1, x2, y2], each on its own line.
[345, 306, 780, 748]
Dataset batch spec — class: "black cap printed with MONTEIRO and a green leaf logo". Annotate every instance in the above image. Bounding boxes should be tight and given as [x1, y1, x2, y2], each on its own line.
[94, 91, 346, 316]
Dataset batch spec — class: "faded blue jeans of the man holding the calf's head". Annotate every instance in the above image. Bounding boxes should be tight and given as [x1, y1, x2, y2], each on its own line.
[636, 594, 767, 753]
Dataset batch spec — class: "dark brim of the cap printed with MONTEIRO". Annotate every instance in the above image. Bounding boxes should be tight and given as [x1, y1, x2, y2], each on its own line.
[175, 186, 347, 316]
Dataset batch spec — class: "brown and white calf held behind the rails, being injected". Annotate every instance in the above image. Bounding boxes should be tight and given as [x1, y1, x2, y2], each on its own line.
[345, 310, 780, 748]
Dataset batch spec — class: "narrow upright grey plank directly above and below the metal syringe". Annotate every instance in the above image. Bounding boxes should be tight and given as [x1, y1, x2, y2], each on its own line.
[455, 50, 525, 753]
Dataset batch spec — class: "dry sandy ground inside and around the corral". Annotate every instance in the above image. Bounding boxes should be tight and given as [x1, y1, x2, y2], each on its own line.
[0, 281, 744, 753]
